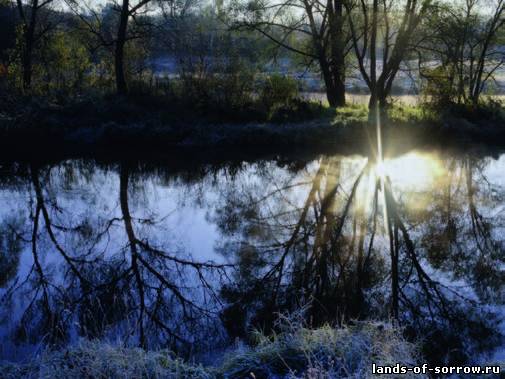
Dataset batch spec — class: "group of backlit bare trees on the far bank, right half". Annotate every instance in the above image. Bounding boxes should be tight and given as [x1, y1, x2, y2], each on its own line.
[237, 0, 505, 108]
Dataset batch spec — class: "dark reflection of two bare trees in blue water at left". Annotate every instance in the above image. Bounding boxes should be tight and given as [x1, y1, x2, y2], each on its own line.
[2, 164, 227, 360]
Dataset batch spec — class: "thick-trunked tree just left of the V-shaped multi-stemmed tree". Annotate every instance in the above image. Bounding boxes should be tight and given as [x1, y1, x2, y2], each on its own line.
[233, 0, 348, 107]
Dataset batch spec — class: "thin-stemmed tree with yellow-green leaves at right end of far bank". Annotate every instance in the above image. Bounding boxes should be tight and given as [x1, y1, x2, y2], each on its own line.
[419, 0, 505, 105]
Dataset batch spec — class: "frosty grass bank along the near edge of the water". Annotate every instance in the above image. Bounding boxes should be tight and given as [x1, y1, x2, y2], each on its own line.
[0, 322, 417, 379]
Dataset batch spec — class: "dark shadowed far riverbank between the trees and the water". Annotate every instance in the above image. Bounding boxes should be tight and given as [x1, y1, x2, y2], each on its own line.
[0, 96, 505, 158]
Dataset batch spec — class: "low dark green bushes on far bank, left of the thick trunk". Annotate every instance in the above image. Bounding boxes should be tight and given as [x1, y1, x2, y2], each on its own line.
[172, 56, 322, 122]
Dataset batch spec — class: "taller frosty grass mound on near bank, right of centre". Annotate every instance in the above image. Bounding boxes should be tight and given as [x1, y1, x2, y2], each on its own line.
[221, 322, 417, 378]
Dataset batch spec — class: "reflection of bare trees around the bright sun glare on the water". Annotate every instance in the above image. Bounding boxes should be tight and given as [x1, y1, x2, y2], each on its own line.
[217, 155, 504, 363]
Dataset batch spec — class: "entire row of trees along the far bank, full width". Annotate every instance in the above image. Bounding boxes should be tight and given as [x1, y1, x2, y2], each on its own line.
[0, 0, 505, 114]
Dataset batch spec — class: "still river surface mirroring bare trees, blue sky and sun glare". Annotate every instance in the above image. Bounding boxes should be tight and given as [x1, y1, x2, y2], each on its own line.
[0, 153, 505, 363]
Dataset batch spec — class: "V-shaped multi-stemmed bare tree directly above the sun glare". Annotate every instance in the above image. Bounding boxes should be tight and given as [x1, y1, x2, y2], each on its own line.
[345, 0, 432, 115]
